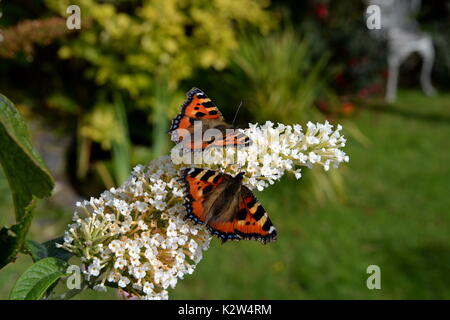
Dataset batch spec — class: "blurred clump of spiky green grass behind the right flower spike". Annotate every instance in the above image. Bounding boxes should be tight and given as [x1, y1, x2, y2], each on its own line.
[232, 27, 331, 124]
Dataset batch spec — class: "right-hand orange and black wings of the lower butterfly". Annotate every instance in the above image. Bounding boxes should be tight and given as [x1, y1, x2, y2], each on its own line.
[208, 186, 277, 244]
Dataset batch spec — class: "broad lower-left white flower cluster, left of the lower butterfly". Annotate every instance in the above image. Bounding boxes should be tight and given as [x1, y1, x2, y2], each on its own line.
[59, 156, 211, 299]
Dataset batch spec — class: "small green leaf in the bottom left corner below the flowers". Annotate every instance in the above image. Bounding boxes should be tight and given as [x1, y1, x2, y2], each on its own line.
[9, 258, 68, 300]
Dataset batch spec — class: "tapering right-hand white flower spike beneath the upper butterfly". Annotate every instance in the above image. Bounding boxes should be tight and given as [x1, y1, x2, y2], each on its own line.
[171, 121, 349, 191]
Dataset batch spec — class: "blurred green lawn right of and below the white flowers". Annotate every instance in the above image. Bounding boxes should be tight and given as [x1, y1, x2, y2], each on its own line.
[0, 91, 450, 299]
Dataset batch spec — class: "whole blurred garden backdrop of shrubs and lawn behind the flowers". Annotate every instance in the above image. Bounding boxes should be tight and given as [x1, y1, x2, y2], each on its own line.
[0, 0, 450, 299]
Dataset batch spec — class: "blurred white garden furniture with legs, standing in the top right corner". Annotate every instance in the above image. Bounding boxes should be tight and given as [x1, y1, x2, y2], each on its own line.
[367, 0, 435, 102]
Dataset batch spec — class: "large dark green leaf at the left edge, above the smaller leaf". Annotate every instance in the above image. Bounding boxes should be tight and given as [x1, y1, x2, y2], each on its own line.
[0, 94, 54, 268]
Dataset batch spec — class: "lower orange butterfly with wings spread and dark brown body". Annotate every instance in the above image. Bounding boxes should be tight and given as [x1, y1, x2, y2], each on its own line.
[181, 168, 277, 243]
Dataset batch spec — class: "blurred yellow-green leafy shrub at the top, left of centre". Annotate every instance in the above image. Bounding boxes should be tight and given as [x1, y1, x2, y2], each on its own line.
[46, 0, 273, 101]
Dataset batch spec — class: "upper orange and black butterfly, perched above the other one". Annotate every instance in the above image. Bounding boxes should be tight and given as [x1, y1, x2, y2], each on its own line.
[169, 88, 251, 151]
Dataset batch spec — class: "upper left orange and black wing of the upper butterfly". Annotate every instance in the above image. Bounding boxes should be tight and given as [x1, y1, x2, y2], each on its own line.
[169, 88, 224, 143]
